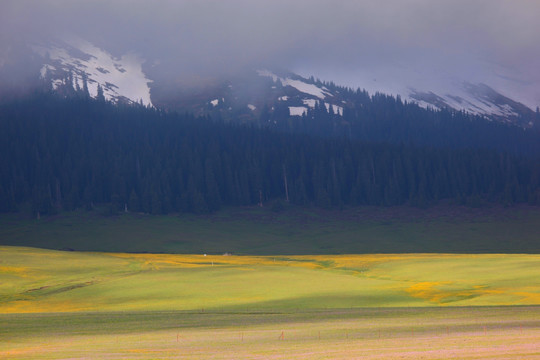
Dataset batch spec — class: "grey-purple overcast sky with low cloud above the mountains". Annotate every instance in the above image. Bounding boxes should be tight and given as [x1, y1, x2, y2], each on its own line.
[0, 0, 540, 106]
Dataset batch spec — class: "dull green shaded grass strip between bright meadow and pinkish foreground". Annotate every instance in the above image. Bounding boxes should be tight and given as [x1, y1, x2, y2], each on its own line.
[0, 306, 540, 341]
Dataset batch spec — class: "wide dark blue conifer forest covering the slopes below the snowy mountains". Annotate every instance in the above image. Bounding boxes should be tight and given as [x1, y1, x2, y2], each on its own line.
[0, 92, 540, 214]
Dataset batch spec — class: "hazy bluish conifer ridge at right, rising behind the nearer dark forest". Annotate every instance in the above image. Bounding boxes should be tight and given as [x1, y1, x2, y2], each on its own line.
[264, 83, 540, 156]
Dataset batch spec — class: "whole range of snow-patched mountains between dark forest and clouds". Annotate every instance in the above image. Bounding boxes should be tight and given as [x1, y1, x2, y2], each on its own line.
[0, 38, 537, 127]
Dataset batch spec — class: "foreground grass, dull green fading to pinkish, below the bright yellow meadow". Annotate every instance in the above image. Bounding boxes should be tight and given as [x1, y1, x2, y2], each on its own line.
[0, 307, 540, 360]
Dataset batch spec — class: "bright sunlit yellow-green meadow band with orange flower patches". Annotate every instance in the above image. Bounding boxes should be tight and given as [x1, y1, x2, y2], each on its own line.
[0, 247, 540, 313]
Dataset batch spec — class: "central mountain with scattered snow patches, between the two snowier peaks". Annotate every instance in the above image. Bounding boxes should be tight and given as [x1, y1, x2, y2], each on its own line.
[148, 68, 352, 122]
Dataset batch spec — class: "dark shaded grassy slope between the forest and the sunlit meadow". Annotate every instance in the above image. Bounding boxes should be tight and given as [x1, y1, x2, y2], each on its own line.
[0, 206, 540, 255]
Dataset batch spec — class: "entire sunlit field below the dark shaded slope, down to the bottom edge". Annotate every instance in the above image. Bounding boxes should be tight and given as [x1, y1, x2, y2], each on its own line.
[0, 246, 540, 359]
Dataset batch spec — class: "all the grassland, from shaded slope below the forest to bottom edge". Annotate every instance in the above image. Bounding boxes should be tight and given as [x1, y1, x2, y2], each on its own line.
[0, 207, 540, 359]
